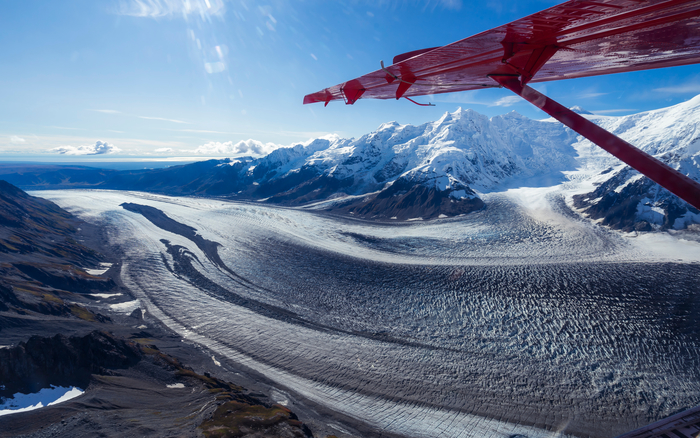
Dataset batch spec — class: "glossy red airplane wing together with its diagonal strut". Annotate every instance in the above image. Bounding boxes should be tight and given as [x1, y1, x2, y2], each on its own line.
[304, 0, 700, 209]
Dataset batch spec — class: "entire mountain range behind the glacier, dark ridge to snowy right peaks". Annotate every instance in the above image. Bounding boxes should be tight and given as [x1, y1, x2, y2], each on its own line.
[0, 96, 700, 226]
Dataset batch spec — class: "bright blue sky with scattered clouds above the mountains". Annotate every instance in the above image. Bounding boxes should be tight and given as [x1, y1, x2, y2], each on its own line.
[0, 0, 700, 161]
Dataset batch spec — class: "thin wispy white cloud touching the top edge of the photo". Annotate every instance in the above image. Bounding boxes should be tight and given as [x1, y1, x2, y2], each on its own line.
[116, 0, 226, 18]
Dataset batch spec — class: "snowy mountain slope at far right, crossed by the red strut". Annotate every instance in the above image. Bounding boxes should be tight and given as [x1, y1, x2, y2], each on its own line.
[574, 96, 700, 231]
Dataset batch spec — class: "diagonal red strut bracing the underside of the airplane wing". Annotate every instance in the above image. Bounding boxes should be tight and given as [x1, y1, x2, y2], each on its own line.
[491, 75, 700, 210]
